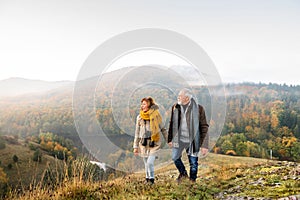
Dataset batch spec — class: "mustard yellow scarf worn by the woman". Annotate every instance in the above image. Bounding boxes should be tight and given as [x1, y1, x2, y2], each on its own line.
[140, 105, 162, 142]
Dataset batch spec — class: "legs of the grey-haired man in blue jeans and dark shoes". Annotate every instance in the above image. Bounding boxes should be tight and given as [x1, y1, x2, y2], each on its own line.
[172, 143, 198, 181]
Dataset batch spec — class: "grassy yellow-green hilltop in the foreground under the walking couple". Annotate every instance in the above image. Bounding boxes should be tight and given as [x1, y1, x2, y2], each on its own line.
[3, 154, 300, 199]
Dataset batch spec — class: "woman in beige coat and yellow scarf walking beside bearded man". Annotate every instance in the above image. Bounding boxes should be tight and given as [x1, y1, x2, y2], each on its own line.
[133, 97, 168, 184]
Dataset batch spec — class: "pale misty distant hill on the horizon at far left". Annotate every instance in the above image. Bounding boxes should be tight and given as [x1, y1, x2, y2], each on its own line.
[0, 78, 73, 97]
